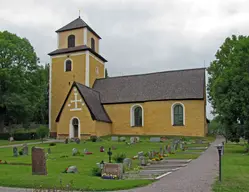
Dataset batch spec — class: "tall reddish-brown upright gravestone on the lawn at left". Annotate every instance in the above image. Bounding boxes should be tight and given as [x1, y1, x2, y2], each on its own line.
[32, 147, 47, 175]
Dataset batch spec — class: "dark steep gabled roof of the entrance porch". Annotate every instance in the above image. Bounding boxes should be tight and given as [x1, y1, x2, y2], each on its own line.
[56, 82, 112, 123]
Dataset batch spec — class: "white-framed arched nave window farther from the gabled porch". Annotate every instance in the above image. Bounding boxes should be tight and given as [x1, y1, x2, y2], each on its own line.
[171, 103, 185, 126]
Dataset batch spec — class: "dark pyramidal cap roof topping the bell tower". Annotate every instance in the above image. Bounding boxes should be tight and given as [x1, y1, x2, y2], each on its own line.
[56, 17, 101, 39]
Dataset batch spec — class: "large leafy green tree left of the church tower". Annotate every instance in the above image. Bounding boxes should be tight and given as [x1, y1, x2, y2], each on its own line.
[0, 31, 40, 132]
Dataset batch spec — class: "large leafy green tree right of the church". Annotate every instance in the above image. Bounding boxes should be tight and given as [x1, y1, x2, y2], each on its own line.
[208, 35, 249, 141]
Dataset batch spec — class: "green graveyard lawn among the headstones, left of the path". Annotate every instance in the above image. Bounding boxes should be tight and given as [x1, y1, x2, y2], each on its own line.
[0, 136, 213, 191]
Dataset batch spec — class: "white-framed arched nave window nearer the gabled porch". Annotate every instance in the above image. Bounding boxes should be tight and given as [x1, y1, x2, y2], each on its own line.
[131, 105, 144, 127]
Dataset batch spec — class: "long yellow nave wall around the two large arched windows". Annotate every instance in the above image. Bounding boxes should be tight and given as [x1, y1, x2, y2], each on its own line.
[104, 100, 206, 136]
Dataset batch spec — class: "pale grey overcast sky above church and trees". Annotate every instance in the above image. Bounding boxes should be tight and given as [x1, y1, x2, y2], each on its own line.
[0, 0, 249, 117]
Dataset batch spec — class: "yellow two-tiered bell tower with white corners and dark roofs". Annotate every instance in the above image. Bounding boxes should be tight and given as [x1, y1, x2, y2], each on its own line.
[48, 17, 107, 137]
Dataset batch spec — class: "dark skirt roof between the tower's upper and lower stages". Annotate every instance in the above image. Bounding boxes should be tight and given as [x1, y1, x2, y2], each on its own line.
[48, 45, 107, 62]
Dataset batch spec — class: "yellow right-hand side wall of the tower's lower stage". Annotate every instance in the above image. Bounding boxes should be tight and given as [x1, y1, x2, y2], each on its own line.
[89, 54, 105, 87]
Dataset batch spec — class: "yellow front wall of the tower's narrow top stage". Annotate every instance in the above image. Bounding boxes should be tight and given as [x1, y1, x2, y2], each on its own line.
[58, 29, 84, 49]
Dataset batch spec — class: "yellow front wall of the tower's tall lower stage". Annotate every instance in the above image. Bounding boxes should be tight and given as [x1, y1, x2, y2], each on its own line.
[51, 53, 86, 132]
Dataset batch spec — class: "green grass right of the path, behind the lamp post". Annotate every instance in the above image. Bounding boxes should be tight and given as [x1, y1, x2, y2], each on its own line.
[213, 144, 249, 192]
